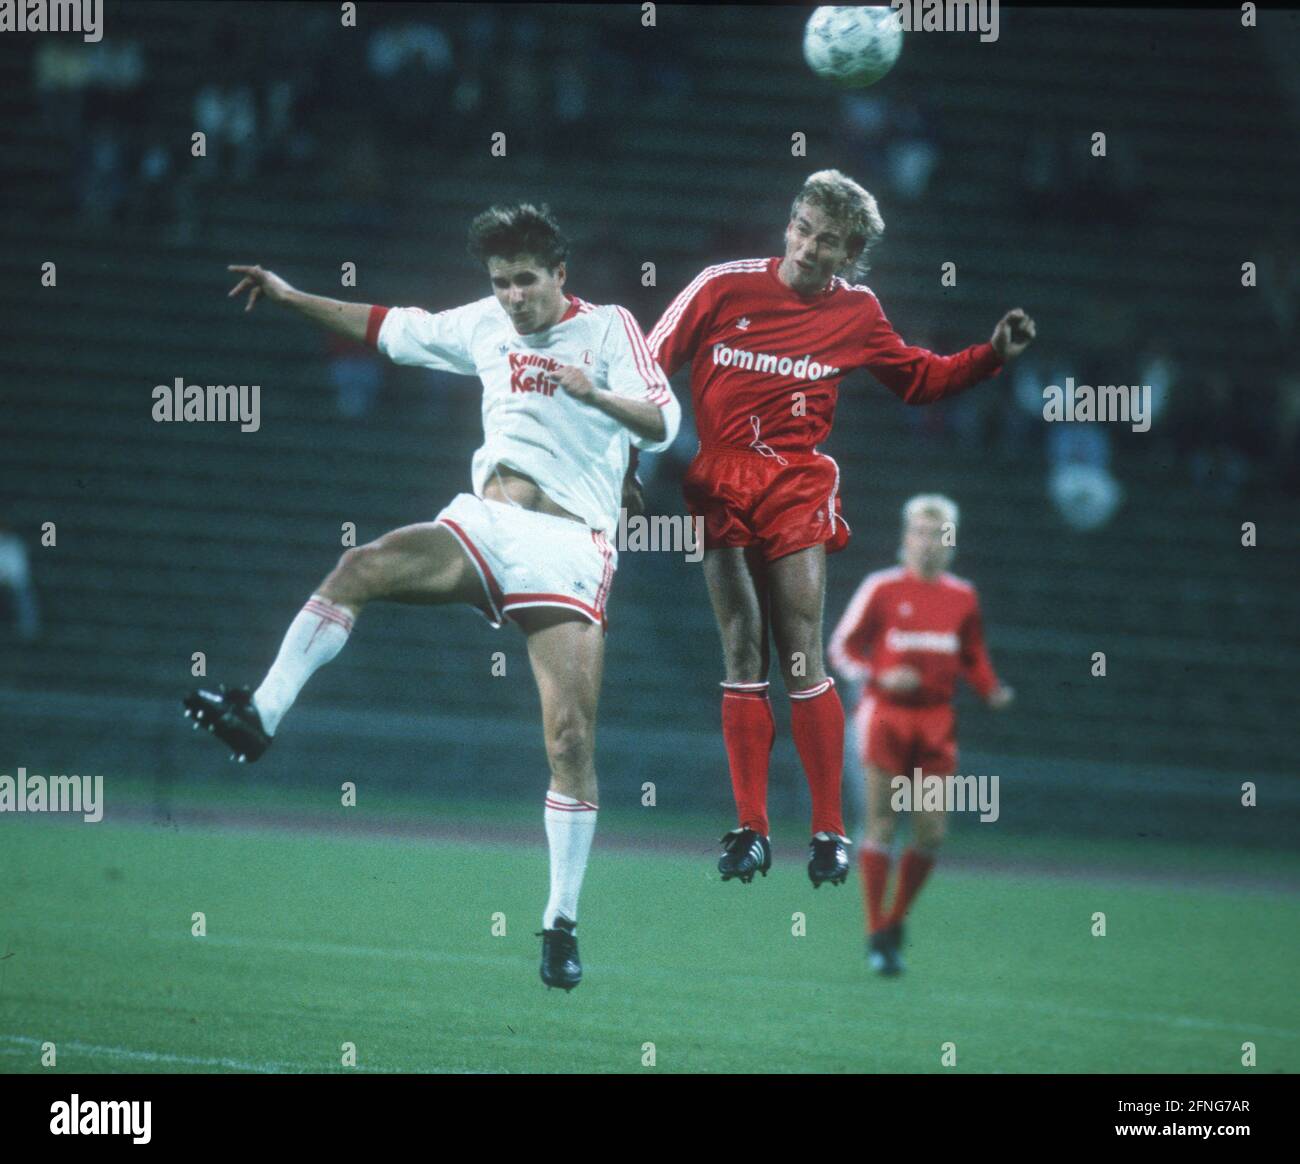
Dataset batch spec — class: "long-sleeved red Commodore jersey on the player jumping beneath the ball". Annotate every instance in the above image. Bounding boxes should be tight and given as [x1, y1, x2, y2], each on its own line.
[649, 258, 1002, 453]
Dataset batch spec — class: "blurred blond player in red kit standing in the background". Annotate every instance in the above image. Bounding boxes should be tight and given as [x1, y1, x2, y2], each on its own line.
[828, 494, 1014, 974]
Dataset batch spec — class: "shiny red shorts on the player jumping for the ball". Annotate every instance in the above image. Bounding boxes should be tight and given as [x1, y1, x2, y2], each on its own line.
[683, 449, 849, 562]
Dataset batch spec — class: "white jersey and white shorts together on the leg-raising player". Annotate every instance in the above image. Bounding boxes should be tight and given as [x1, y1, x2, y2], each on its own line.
[367, 280, 681, 626]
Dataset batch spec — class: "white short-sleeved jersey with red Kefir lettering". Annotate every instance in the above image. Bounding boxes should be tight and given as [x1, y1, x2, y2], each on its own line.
[368, 295, 681, 533]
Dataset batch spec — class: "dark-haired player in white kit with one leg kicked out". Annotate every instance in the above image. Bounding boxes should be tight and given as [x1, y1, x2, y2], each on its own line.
[183, 203, 681, 990]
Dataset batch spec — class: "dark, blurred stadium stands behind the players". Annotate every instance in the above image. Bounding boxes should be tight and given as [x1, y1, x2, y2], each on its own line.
[0, 3, 1300, 849]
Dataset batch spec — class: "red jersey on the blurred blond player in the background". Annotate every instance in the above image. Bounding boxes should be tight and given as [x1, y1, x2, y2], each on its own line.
[828, 566, 998, 708]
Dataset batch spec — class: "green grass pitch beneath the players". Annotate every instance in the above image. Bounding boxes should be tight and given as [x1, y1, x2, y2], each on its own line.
[0, 789, 1300, 1073]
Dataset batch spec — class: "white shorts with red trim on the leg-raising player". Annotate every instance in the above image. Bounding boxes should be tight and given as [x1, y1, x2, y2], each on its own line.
[434, 493, 619, 628]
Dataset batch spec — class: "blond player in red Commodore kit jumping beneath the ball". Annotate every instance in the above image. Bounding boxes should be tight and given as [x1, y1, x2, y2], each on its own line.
[649, 170, 1035, 887]
